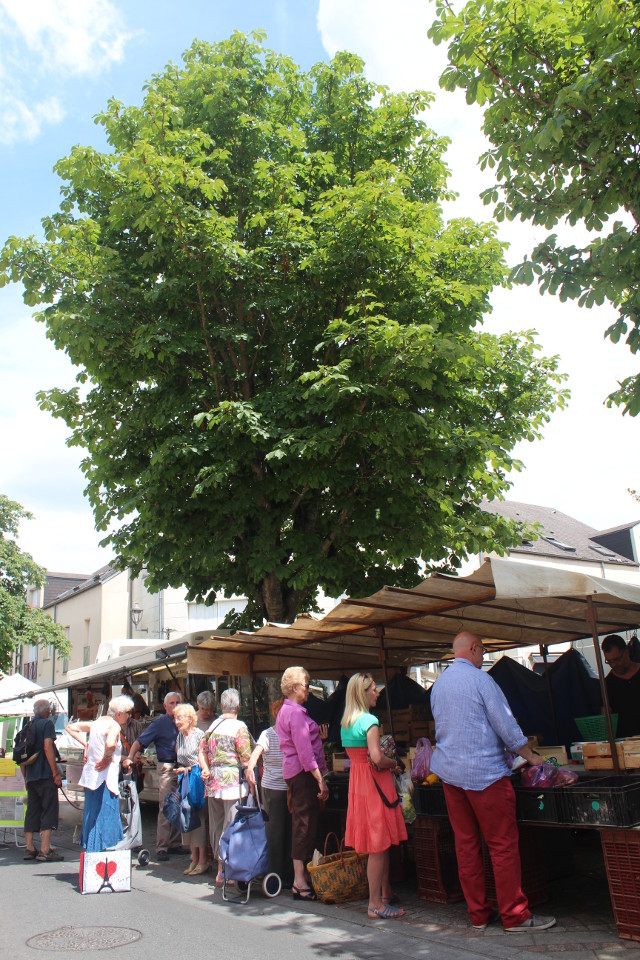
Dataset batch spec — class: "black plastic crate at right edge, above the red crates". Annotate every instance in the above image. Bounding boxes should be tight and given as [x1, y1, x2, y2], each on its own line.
[558, 777, 640, 827]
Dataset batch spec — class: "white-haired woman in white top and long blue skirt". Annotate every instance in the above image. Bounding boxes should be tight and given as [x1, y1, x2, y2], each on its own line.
[65, 697, 133, 853]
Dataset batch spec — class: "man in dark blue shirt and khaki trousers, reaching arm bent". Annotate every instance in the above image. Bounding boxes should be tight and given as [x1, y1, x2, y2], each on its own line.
[122, 691, 182, 860]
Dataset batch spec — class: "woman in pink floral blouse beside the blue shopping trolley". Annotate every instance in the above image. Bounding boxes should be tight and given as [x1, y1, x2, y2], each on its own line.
[200, 687, 253, 887]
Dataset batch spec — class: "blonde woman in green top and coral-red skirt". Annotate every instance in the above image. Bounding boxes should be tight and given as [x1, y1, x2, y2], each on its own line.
[341, 673, 407, 920]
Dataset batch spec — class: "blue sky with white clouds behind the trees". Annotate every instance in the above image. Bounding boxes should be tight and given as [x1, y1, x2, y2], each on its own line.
[0, 0, 640, 573]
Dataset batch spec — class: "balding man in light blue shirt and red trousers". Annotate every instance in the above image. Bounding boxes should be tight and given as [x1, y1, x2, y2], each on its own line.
[431, 631, 556, 933]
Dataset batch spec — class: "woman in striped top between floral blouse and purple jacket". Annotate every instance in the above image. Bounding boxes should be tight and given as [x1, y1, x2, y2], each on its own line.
[246, 699, 293, 889]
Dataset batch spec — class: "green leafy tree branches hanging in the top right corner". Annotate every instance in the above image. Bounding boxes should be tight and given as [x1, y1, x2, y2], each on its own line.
[429, 0, 640, 416]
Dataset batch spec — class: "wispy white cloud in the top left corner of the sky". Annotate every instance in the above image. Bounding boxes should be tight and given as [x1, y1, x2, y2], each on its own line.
[0, 0, 130, 74]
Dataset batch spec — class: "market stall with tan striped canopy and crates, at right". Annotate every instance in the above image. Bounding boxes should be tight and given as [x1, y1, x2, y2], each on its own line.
[190, 560, 640, 939]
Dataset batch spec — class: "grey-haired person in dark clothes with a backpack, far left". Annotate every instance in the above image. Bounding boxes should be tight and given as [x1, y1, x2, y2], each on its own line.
[22, 700, 64, 863]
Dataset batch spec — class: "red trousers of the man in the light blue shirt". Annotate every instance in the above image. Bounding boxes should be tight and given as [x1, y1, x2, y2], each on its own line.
[444, 777, 531, 929]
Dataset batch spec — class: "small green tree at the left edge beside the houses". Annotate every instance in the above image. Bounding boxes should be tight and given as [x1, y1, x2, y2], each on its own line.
[0, 494, 71, 671]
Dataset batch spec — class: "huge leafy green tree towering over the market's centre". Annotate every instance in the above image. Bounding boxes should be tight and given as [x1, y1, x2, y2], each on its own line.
[0, 34, 564, 621]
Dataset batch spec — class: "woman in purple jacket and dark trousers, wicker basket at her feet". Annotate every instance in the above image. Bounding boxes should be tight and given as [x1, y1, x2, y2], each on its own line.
[276, 667, 329, 900]
